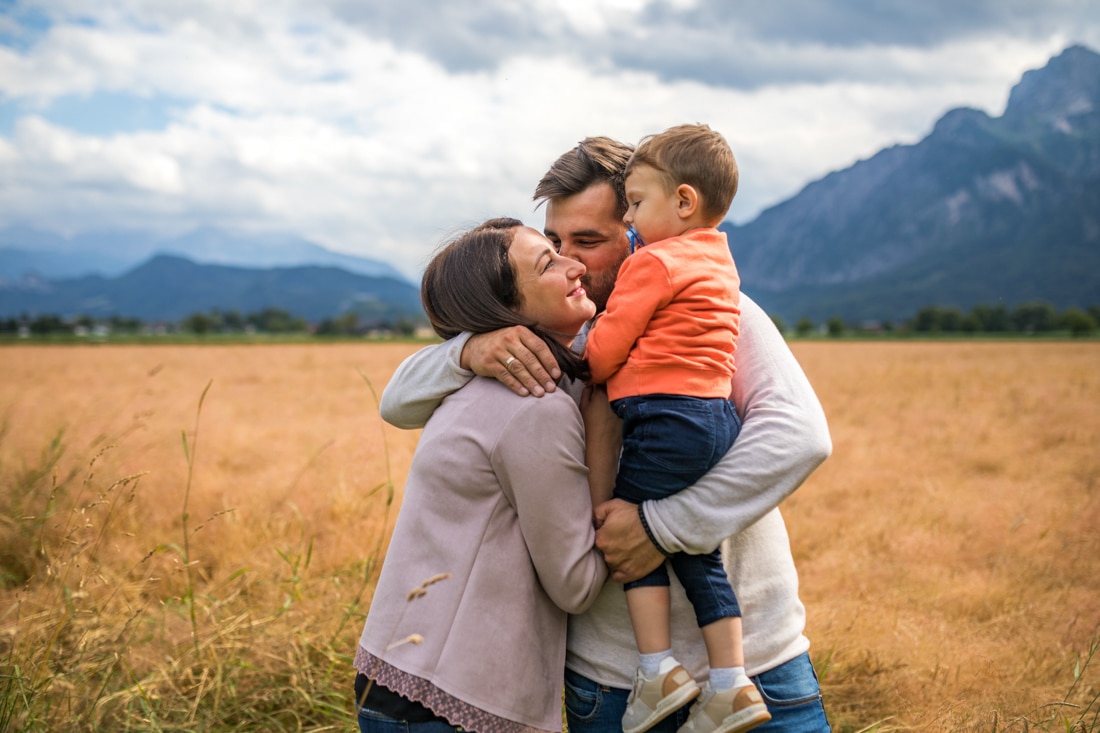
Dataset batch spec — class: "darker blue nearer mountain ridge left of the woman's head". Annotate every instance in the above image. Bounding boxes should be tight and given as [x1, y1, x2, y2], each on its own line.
[0, 254, 424, 325]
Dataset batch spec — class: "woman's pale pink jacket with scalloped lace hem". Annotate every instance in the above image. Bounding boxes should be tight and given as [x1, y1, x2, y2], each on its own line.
[355, 378, 607, 733]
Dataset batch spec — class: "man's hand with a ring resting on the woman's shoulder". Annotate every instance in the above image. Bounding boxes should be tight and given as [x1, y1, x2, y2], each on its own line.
[459, 326, 561, 397]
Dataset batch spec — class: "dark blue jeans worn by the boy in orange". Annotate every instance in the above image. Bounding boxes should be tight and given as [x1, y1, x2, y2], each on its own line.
[612, 394, 741, 627]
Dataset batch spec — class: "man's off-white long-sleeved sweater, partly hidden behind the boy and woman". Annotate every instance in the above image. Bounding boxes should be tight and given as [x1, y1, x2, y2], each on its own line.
[382, 294, 832, 689]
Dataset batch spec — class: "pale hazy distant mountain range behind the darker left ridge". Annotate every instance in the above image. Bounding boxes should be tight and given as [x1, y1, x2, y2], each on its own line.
[0, 227, 406, 281]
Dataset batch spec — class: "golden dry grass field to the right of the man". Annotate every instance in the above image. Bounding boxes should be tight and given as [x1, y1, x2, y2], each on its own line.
[784, 342, 1100, 731]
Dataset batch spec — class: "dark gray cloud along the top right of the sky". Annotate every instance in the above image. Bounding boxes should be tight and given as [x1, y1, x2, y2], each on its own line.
[607, 0, 1100, 89]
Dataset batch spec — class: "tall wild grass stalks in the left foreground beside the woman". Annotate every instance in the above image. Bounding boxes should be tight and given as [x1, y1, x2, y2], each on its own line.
[0, 378, 395, 732]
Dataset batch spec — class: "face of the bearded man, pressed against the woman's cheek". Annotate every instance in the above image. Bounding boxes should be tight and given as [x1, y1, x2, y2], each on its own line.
[545, 183, 630, 311]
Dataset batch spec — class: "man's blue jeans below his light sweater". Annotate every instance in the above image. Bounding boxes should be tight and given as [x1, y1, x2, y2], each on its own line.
[563, 654, 832, 733]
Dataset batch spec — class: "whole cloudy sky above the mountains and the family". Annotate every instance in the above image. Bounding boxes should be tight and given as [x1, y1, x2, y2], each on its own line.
[0, 0, 1100, 276]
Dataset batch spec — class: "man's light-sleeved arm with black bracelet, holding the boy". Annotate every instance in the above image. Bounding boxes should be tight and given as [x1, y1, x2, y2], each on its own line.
[596, 295, 833, 581]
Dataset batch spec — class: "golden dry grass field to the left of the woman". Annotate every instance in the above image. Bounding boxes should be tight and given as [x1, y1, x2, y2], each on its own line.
[0, 344, 415, 730]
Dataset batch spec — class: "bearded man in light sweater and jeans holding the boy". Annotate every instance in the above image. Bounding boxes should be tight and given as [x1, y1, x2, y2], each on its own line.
[382, 138, 832, 733]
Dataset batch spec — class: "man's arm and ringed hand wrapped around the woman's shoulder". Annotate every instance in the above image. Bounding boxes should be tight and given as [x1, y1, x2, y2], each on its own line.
[380, 326, 561, 429]
